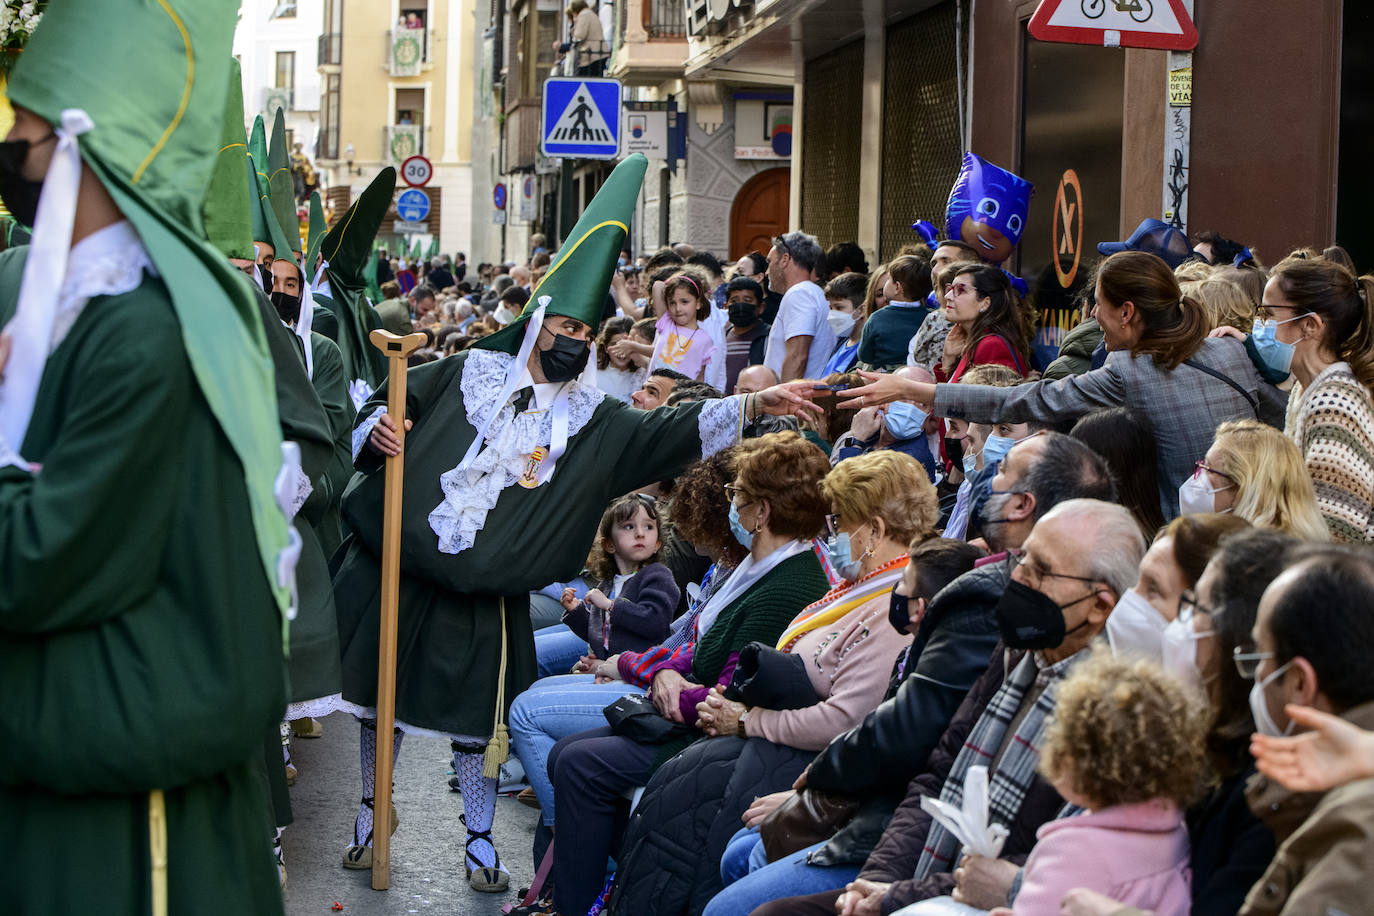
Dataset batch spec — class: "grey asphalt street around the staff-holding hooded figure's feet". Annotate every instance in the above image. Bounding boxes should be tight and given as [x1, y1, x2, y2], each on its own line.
[282, 713, 537, 916]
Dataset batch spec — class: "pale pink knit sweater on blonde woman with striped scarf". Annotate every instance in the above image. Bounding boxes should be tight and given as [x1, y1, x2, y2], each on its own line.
[745, 592, 911, 751]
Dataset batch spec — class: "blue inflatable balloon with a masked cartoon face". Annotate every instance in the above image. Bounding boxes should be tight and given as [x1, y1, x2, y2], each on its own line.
[945, 152, 1033, 264]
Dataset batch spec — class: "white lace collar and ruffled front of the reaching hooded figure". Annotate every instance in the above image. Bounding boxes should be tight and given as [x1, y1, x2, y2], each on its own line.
[429, 350, 606, 553]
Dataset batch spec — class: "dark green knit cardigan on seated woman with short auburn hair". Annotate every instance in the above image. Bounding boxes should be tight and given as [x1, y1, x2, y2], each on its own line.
[654, 551, 830, 770]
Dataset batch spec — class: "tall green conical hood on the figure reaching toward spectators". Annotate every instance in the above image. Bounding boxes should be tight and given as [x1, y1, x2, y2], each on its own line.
[473, 152, 649, 353]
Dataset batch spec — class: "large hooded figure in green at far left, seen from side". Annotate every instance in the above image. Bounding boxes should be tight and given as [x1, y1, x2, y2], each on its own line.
[0, 0, 300, 913]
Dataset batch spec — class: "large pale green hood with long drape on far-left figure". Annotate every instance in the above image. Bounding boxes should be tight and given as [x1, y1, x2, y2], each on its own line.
[8, 0, 289, 620]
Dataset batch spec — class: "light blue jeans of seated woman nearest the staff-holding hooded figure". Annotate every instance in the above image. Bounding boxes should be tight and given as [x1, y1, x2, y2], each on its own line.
[508, 672, 644, 827]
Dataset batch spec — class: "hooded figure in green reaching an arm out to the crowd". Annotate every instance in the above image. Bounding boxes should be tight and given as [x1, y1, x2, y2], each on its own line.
[334, 155, 807, 889]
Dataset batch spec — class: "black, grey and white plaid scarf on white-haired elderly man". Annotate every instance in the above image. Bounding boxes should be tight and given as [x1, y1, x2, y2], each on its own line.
[914, 652, 1081, 880]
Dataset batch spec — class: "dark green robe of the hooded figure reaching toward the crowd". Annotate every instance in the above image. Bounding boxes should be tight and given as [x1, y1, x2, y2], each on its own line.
[334, 352, 725, 737]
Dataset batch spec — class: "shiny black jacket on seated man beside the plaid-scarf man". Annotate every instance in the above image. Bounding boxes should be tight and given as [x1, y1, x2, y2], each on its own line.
[807, 563, 1010, 865]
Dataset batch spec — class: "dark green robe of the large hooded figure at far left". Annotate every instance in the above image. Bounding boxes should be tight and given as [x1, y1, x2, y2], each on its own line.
[0, 256, 286, 913]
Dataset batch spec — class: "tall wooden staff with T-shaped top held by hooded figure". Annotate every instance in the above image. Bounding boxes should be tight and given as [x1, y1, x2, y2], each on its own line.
[368, 330, 425, 890]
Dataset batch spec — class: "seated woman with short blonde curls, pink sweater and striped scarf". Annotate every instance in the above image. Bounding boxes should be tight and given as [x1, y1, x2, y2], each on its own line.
[611, 452, 937, 916]
